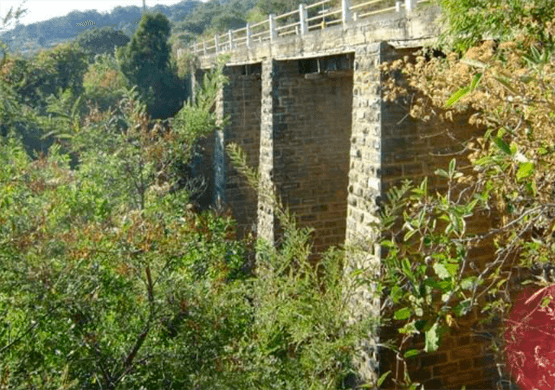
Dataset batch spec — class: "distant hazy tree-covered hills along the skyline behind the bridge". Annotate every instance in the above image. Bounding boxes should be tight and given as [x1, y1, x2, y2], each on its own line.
[0, 0, 338, 56]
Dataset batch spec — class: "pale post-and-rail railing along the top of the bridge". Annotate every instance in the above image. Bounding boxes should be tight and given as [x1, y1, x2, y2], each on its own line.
[182, 0, 429, 56]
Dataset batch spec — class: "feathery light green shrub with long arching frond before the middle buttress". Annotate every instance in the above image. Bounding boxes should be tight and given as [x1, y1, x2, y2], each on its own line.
[228, 144, 370, 390]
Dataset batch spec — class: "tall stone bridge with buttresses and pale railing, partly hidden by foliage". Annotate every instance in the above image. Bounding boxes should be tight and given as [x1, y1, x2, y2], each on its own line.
[181, 0, 495, 389]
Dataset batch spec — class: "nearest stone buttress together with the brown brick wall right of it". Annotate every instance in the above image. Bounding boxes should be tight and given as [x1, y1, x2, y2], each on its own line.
[346, 43, 496, 390]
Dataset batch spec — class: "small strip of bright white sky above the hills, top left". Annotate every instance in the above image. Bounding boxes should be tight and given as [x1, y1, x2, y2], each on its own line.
[0, 0, 191, 31]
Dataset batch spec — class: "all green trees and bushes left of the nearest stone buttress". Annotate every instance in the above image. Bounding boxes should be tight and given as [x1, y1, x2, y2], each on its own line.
[0, 3, 374, 390]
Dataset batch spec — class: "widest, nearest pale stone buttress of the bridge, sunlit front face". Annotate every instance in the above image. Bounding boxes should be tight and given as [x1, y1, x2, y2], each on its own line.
[345, 43, 387, 383]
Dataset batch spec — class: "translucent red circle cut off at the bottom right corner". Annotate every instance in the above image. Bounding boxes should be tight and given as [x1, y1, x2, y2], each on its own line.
[505, 285, 555, 390]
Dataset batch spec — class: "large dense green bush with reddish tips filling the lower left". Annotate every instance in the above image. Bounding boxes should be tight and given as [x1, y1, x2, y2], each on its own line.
[0, 59, 252, 389]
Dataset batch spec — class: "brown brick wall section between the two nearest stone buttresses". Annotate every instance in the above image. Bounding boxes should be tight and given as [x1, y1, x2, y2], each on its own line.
[273, 57, 352, 252]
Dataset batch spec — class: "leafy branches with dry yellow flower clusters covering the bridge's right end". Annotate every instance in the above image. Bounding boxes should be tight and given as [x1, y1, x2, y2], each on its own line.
[381, 0, 555, 389]
